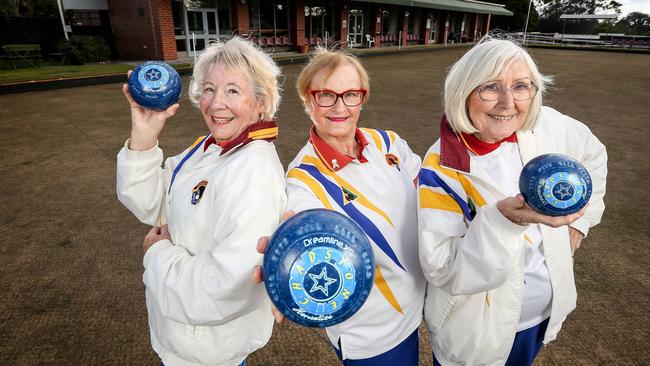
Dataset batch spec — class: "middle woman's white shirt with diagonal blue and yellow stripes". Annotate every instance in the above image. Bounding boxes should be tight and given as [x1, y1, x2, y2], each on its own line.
[287, 128, 426, 360]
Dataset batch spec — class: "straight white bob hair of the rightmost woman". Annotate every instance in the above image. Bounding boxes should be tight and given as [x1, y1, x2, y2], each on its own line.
[444, 35, 551, 134]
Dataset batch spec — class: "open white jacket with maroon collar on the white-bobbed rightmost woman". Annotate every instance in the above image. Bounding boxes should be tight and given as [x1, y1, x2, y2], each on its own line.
[418, 107, 607, 365]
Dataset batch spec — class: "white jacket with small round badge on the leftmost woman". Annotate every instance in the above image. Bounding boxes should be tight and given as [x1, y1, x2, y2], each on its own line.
[117, 129, 286, 366]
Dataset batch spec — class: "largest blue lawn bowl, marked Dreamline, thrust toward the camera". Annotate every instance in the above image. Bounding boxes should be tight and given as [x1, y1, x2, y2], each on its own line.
[262, 209, 375, 328]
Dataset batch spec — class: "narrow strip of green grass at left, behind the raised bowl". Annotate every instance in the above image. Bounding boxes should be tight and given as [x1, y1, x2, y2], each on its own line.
[0, 64, 189, 84]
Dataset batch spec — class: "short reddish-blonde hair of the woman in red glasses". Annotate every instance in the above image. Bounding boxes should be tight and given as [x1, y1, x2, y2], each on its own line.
[296, 47, 370, 110]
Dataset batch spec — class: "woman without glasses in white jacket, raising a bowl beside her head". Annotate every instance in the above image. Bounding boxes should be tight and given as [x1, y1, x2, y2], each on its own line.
[117, 38, 286, 366]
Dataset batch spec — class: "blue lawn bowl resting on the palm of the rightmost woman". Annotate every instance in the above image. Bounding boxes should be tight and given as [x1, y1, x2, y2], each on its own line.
[519, 154, 592, 216]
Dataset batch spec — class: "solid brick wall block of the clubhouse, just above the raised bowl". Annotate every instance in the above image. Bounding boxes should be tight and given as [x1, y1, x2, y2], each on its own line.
[109, 0, 177, 60]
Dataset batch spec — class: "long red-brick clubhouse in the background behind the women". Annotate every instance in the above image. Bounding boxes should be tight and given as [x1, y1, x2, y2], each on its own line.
[63, 0, 512, 60]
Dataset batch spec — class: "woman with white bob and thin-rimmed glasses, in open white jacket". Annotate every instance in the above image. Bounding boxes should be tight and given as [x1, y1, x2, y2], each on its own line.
[418, 38, 607, 366]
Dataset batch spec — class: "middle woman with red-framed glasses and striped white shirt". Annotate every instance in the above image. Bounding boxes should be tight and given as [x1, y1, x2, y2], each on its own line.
[270, 49, 425, 366]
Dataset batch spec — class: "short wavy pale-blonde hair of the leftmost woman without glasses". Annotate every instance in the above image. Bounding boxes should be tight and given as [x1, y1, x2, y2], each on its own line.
[189, 37, 281, 120]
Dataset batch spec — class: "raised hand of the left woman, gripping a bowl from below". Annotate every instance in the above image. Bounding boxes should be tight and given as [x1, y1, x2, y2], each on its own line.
[122, 70, 180, 151]
